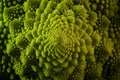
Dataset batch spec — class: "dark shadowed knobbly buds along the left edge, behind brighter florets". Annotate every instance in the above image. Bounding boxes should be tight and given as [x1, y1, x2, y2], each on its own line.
[0, 21, 18, 80]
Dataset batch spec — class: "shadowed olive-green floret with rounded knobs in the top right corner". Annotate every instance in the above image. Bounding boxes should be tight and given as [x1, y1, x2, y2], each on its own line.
[89, 0, 119, 17]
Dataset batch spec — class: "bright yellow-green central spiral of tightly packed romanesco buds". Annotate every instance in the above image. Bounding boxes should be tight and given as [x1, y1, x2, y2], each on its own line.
[36, 14, 79, 77]
